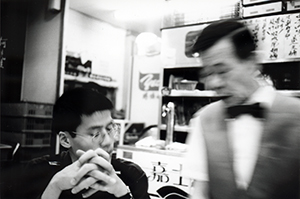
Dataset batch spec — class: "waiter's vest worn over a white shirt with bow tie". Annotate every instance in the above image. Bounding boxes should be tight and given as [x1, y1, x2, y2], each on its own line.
[200, 94, 300, 199]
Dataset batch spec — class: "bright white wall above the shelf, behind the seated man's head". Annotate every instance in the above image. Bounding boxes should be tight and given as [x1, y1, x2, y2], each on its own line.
[65, 9, 128, 110]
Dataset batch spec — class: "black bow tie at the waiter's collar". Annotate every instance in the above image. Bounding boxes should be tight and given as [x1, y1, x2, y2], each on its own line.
[227, 103, 264, 118]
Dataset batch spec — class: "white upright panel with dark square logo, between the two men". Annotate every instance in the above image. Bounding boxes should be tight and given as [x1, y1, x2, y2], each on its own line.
[130, 55, 162, 126]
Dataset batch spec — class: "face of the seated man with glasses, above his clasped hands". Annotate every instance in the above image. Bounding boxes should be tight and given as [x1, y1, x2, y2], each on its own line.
[70, 110, 114, 160]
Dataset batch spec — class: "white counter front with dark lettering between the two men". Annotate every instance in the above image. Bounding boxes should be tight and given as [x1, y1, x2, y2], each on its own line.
[117, 144, 191, 199]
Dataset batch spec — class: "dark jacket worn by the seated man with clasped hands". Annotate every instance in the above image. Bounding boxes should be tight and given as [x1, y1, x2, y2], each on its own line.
[15, 152, 150, 199]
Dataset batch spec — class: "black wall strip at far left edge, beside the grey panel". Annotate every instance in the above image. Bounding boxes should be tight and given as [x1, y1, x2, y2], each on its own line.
[1, 1, 27, 102]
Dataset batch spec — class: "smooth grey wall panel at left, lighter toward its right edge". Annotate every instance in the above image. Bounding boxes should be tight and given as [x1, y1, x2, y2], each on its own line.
[21, 0, 63, 104]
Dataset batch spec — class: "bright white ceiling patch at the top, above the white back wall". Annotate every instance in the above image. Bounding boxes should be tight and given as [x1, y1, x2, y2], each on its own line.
[69, 0, 166, 37]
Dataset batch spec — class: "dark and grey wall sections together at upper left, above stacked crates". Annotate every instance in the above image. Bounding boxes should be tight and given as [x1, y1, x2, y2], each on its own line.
[1, 0, 62, 103]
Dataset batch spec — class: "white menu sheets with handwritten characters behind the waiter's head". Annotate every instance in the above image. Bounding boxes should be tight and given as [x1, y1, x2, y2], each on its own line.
[244, 13, 300, 61]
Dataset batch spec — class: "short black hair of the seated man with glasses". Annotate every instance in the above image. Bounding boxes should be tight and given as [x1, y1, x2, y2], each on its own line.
[52, 88, 113, 133]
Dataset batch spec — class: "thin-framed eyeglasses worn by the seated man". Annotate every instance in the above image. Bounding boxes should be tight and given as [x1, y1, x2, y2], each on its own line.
[71, 122, 120, 143]
